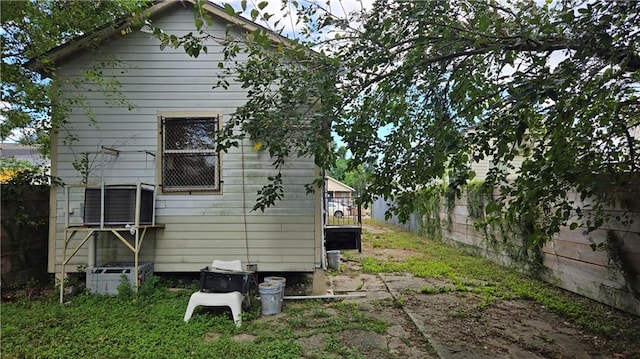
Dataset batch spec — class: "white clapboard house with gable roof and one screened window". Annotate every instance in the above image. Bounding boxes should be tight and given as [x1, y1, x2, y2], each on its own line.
[30, 0, 325, 291]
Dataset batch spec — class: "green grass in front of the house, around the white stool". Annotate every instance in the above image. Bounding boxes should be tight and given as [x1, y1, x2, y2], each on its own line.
[1, 281, 388, 359]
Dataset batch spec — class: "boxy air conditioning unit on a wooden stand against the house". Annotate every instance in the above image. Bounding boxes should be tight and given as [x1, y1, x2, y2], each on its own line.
[84, 185, 154, 226]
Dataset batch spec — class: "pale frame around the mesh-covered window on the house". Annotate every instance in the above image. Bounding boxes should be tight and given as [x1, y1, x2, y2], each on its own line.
[157, 112, 223, 194]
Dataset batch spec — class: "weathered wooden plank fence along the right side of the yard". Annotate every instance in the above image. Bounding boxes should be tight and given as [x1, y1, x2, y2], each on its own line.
[372, 190, 640, 315]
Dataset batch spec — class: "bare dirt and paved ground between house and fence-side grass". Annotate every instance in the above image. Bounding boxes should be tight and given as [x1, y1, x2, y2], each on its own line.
[322, 227, 640, 359]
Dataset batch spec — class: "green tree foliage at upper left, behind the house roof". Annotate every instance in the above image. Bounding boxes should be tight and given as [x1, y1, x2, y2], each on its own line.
[0, 0, 147, 151]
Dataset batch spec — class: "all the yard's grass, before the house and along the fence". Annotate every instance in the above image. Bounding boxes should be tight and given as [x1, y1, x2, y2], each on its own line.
[1, 224, 640, 359]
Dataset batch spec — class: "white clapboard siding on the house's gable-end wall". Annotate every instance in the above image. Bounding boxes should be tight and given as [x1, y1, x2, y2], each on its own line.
[49, 5, 321, 272]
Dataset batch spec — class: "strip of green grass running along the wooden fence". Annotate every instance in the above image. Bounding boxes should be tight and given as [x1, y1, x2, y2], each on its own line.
[361, 220, 640, 348]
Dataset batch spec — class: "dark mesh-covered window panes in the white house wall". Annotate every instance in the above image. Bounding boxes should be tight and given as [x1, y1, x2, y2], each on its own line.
[162, 116, 220, 192]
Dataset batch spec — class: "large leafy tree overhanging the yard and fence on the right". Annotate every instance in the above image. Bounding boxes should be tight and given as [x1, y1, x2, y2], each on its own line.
[198, 0, 640, 244]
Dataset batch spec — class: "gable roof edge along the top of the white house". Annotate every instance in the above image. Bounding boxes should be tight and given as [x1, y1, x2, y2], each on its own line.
[26, 0, 288, 74]
